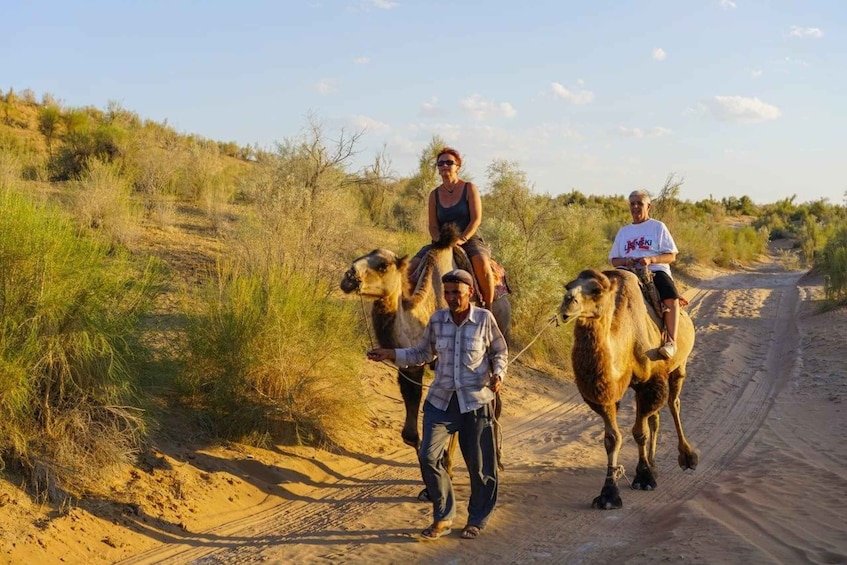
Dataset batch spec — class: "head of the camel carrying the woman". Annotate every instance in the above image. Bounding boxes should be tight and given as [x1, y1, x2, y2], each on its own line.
[340, 249, 409, 299]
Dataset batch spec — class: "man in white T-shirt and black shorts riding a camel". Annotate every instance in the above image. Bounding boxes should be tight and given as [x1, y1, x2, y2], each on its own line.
[609, 190, 680, 359]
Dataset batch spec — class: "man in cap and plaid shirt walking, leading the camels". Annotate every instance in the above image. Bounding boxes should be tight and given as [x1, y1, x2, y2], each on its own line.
[368, 269, 508, 540]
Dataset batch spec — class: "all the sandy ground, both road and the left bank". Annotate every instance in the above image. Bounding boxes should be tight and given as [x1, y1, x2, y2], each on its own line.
[0, 261, 847, 565]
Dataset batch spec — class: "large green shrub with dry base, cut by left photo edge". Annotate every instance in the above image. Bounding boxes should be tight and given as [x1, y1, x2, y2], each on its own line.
[0, 184, 157, 497]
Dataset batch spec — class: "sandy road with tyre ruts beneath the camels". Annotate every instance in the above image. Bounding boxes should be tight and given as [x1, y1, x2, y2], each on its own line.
[119, 265, 847, 564]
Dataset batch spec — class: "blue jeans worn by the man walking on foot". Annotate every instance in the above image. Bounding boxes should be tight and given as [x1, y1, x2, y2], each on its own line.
[418, 394, 498, 528]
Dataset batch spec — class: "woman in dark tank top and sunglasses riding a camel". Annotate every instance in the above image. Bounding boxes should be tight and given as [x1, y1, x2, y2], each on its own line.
[409, 147, 494, 309]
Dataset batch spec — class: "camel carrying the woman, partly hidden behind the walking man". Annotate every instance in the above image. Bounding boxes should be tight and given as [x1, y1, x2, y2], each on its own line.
[340, 224, 511, 495]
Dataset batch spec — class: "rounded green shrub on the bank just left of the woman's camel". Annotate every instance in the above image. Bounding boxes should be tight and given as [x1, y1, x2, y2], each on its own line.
[179, 260, 364, 445]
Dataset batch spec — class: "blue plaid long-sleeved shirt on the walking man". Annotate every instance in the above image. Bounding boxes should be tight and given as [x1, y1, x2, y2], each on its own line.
[396, 306, 509, 414]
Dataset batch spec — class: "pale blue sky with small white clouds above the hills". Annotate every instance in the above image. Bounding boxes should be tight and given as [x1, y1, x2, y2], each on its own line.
[0, 0, 847, 204]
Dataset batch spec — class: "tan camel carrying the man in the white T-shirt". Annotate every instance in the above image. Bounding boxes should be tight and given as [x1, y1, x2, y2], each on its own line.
[559, 269, 699, 510]
